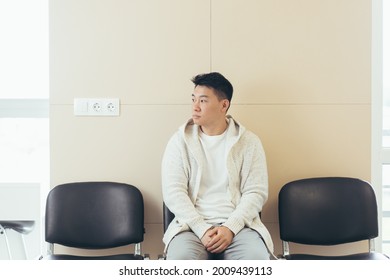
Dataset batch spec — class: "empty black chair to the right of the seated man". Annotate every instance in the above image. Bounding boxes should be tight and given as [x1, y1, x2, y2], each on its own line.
[278, 177, 388, 260]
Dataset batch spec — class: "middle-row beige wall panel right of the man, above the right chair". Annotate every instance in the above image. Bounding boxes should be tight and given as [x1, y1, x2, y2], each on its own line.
[230, 105, 371, 222]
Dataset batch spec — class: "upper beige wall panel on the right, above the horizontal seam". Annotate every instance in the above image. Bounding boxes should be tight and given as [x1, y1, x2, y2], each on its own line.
[211, 0, 371, 104]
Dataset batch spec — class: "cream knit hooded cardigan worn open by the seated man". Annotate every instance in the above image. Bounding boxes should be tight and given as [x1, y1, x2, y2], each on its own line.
[161, 116, 273, 253]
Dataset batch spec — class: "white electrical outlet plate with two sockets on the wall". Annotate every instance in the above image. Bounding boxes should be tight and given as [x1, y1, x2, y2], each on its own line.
[74, 98, 119, 116]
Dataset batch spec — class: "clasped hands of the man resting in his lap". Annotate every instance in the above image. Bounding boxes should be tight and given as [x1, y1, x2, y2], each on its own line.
[201, 226, 234, 253]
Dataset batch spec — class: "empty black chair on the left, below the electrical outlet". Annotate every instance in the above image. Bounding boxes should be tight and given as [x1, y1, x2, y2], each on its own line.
[44, 182, 145, 260]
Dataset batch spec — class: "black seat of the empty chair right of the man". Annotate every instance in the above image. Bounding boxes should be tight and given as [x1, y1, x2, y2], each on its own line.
[284, 252, 389, 260]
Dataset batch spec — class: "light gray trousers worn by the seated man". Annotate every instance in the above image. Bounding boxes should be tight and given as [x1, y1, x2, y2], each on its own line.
[167, 228, 270, 260]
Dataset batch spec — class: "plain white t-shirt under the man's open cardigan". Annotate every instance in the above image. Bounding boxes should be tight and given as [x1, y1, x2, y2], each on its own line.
[195, 128, 234, 225]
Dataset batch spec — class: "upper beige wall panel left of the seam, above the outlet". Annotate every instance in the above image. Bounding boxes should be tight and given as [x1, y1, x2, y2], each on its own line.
[50, 0, 210, 104]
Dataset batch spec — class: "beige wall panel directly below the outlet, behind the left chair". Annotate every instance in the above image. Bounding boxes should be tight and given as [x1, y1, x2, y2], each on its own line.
[50, 105, 190, 223]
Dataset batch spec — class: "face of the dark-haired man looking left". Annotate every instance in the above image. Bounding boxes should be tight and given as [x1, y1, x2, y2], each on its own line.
[192, 86, 229, 127]
